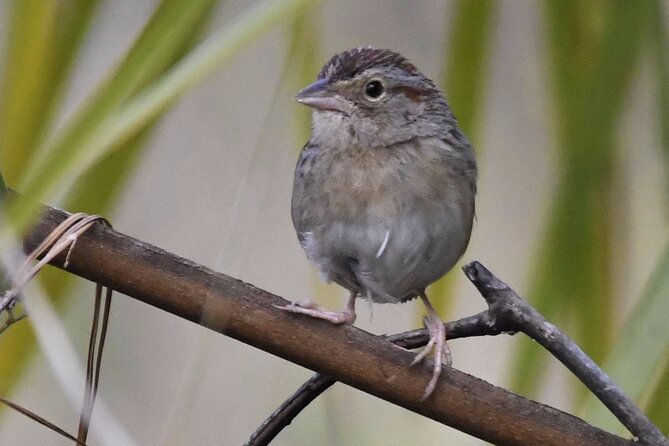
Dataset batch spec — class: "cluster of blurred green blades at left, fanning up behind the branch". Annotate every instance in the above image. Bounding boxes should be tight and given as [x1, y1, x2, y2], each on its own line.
[0, 0, 320, 393]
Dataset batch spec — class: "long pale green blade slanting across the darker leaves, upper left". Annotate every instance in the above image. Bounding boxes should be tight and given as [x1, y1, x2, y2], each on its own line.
[3, 0, 314, 242]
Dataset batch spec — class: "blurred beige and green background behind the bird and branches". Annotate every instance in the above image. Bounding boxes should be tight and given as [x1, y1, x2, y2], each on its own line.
[0, 0, 669, 445]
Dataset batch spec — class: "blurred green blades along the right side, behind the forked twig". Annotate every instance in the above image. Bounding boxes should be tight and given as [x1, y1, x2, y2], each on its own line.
[506, 0, 669, 432]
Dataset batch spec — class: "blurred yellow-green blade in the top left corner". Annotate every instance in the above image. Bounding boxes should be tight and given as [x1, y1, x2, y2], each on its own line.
[0, 0, 99, 184]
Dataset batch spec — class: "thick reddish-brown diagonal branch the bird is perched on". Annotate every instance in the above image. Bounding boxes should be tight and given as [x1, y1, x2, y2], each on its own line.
[24, 208, 636, 446]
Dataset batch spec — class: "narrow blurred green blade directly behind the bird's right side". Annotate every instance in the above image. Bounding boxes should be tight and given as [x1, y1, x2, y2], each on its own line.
[429, 0, 499, 319]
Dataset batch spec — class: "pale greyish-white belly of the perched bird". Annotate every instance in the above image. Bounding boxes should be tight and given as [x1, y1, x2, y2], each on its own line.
[307, 204, 469, 303]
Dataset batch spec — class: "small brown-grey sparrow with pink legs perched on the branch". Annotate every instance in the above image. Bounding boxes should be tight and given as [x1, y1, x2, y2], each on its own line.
[281, 47, 476, 399]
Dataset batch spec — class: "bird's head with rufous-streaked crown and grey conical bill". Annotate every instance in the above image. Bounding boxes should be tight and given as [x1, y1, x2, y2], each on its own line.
[295, 47, 454, 147]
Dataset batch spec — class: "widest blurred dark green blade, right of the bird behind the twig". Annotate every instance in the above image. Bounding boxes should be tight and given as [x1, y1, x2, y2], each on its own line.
[512, 0, 651, 394]
